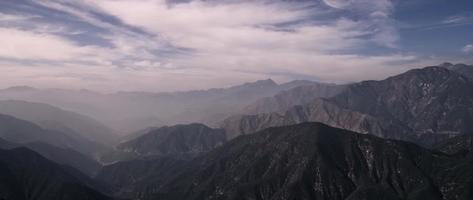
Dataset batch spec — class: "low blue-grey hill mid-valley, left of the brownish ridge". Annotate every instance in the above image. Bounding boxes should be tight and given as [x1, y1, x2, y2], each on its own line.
[102, 123, 226, 162]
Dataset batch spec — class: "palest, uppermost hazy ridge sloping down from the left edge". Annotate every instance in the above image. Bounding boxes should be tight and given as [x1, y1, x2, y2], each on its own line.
[0, 100, 117, 143]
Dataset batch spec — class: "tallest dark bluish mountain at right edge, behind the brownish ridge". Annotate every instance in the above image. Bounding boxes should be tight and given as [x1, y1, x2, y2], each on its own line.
[331, 67, 473, 134]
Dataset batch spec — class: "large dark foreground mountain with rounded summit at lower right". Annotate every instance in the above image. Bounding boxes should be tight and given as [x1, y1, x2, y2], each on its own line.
[102, 123, 473, 200]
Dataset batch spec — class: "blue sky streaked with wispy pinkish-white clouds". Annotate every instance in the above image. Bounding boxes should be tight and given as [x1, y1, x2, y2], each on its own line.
[0, 0, 473, 91]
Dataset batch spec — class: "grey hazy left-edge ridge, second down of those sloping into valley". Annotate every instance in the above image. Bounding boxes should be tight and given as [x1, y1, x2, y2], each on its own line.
[0, 114, 104, 156]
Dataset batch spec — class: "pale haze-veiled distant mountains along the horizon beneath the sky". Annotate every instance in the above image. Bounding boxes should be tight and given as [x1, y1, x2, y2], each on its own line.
[0, 79, 314, 133]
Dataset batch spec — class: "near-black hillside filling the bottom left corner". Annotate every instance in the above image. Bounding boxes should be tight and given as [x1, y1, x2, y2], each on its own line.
[0, 148, 112, 200]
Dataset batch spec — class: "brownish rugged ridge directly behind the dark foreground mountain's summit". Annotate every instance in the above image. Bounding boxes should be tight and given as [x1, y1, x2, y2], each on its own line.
[222, 99, 413, 140]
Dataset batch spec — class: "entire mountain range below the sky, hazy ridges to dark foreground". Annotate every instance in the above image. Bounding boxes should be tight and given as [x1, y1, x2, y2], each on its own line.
[0, 63, 473, 200]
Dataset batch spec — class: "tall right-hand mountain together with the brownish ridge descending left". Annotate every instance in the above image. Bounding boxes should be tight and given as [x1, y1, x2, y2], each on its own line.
[222, 67, 473, 144]
